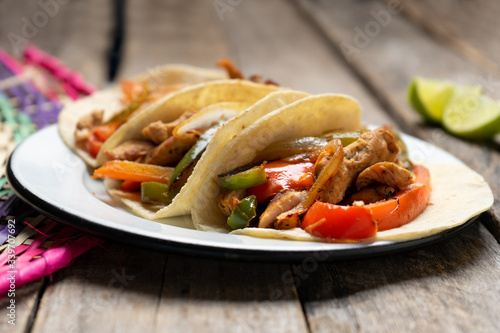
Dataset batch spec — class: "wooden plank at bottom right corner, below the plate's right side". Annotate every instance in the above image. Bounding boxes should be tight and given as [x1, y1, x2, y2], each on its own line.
[298, 224, 500, 333]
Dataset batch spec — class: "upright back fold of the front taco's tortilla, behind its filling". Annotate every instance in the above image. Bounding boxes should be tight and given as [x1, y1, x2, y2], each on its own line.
[191, 94, 361, 233]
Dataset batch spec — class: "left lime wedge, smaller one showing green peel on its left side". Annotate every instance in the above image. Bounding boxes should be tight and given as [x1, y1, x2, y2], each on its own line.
[408, 77, 457, 123]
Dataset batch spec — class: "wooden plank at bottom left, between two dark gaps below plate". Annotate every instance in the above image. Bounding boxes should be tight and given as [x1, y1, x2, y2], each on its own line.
[32, 242, 166, 333]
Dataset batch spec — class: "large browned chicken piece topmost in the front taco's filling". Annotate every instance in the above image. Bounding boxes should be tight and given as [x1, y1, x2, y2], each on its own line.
[315, 128, 398, 204]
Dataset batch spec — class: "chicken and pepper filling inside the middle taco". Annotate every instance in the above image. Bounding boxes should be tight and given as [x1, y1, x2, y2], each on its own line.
[94, 102, 248, 204]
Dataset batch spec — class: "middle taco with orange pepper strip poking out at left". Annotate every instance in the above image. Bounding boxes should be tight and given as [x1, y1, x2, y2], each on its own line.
[94, 80, 308, 220]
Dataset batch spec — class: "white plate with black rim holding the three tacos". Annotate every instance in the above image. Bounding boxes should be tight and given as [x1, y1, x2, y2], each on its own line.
[7, 125, 472, 261]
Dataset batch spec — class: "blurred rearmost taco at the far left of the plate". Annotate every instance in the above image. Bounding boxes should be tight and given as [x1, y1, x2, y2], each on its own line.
[58, 64, 228, 167]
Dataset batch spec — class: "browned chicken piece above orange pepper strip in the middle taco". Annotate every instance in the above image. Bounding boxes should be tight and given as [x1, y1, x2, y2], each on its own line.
[144, 131, 200, 165]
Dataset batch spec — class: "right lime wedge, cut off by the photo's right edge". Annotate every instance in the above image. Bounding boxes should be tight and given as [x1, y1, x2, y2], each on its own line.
[443, 89, 500, 139]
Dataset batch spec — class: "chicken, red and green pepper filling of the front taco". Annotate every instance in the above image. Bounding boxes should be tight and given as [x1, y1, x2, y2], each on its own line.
[218, 128, 430, 239]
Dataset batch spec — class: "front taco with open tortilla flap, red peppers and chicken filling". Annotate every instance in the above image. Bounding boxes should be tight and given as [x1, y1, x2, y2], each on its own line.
[192, 94, 493, 242]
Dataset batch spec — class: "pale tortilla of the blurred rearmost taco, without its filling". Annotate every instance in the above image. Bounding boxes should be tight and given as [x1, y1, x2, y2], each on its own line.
[58, 64, 227, 167]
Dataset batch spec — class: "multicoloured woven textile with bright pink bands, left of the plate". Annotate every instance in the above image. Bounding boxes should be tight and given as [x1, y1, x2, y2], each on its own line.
[0, 46, 103, 296]
